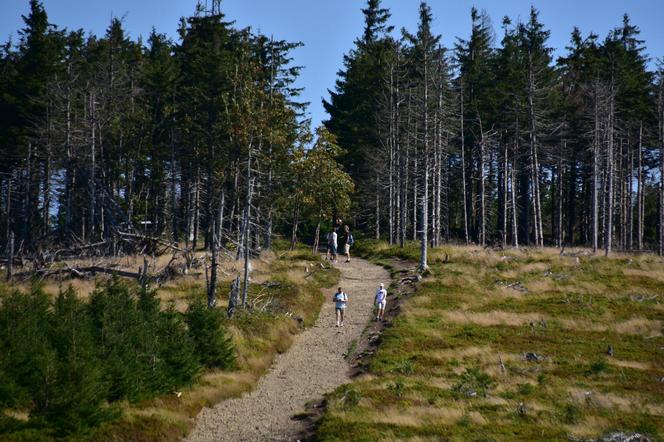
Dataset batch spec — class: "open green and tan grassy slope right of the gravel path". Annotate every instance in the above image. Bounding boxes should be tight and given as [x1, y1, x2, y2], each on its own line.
[318, 244, 664, 441]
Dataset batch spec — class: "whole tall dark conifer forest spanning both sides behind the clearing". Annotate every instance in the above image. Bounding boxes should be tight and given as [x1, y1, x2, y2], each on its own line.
[0, 1, 664, 266]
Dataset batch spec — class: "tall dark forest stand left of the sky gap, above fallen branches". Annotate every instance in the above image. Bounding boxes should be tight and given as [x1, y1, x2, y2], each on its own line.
[0, 0, 350, 258]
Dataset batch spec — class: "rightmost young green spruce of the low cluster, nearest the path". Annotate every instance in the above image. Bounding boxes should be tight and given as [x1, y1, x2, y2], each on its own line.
[185, 300, 235, 369]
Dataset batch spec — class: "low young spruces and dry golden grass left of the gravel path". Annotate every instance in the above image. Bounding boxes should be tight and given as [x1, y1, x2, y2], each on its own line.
[0, 243, 338, 441]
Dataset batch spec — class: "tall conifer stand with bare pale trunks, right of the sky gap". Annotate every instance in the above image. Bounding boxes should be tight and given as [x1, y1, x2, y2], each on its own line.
[324, 0, 664, 264]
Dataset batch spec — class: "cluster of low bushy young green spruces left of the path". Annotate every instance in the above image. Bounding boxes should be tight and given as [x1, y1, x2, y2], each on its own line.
[0, 281, 235, 440]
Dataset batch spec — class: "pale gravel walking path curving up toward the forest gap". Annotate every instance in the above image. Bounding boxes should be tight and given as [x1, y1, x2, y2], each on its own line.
[187, 259, 389, 441]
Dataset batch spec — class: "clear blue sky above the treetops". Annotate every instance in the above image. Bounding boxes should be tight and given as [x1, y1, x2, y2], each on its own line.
[0, 0, 664, 129]
